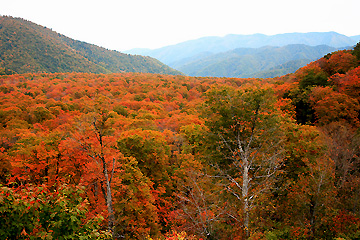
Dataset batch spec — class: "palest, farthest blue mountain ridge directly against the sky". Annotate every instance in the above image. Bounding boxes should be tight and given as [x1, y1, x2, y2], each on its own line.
[125, 32, 358, 67]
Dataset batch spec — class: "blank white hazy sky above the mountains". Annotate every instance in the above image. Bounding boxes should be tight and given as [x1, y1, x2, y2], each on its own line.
[0, 0, 360, 51]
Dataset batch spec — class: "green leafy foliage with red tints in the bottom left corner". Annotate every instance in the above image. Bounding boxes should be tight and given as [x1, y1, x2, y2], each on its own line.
[0, 186, 110, 239]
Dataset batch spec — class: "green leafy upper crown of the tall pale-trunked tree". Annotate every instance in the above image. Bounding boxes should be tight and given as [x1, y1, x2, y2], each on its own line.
[204, 86, 281, 165]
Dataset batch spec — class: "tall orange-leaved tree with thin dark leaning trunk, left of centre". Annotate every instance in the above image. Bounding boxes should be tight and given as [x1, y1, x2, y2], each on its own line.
[73, 96, 121, 237]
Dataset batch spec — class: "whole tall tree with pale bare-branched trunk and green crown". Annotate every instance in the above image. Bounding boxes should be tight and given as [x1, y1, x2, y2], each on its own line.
[206, 87, 284, 238]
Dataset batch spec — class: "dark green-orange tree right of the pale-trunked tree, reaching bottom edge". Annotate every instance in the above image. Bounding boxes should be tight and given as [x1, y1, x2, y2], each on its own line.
[274, 125, 335, 239]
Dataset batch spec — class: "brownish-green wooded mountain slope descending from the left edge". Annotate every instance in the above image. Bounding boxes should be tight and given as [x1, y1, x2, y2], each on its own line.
[0, 16, 181, 75]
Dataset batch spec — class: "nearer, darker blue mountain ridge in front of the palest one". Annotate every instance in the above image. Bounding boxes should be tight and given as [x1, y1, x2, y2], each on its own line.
[178, 44, 337, 78]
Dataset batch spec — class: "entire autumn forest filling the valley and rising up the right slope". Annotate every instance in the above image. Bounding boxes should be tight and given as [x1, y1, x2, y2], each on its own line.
[0, 44, 360, 239]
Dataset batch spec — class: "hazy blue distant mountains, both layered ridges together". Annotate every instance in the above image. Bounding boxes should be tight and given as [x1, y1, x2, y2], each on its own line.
[127, 32, 360, 77]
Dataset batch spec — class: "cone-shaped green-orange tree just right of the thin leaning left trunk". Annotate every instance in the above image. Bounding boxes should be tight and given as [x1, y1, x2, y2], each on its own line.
[114, 157, 160, 239]
